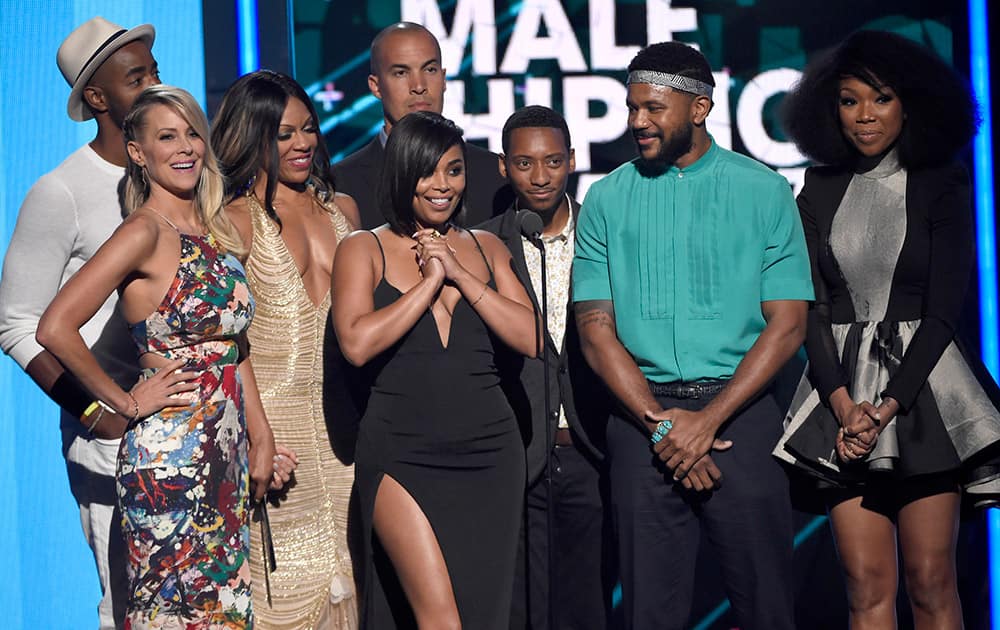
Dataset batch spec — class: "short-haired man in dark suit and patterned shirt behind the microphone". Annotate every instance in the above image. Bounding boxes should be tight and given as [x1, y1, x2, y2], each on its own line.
[479, 106, 611, 630]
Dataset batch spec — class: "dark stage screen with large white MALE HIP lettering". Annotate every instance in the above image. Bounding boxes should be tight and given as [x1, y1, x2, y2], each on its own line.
[293, 0, 965, 200]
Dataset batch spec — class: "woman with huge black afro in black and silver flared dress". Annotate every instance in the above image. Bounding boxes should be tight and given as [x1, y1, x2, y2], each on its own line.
[775, 31, 1000, 629]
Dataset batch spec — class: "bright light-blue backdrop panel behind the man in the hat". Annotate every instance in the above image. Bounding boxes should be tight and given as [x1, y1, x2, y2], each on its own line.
[0, 0, 205, 629]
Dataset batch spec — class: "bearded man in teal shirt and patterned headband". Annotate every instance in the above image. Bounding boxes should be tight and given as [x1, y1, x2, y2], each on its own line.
[573, 42, 813, 629]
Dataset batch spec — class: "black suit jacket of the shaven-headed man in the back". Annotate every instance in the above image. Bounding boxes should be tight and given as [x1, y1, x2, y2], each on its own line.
[333, 136, 514, 230]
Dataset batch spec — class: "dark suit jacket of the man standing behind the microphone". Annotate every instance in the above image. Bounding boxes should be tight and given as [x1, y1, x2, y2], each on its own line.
[478, 201, 610, 484]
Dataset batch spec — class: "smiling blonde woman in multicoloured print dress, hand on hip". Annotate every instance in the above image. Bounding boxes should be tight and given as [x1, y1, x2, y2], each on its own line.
[37, 85, 294, 628]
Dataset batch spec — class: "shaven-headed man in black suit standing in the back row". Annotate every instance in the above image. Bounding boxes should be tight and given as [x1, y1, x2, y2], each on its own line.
[333, 22, 513, 230]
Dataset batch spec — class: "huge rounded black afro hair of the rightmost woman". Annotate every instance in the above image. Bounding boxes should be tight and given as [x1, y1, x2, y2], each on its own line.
[783, 31, 979, 169]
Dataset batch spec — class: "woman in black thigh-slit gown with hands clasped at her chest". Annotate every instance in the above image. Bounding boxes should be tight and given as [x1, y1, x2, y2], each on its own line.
[332, 112, 537, 630]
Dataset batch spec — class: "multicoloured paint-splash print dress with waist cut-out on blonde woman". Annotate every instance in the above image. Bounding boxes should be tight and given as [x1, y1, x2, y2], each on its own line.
[123, 233, 254, 629]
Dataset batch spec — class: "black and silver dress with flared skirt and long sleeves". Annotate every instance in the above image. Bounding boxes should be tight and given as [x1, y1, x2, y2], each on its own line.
[774, 151, 1000, 504]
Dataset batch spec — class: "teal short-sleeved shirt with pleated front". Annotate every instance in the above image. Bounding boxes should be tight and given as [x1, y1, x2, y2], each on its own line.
[573, 141, 813, 383]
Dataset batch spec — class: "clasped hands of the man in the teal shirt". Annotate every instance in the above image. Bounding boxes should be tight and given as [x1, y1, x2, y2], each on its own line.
[643, 409, 733, 492]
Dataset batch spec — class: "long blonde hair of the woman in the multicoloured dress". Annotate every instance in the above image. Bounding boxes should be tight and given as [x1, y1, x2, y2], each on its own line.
[122, 85, 247, 259]
